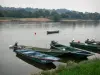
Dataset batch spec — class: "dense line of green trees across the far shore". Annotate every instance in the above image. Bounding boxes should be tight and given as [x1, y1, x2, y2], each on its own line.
[0, 6, 100, 21]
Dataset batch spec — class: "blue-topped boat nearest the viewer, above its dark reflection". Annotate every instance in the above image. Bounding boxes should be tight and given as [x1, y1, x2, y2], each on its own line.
[15, 49, 60, 64]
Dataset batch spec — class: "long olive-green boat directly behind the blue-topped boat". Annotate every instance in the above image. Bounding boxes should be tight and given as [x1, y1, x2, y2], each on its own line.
[9, 45, 65, 56]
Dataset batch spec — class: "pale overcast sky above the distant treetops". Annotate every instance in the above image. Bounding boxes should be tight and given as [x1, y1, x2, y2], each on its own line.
[0, 0, 100, 13]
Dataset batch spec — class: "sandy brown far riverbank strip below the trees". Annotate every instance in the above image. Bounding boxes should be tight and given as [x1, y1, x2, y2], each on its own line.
[0, 17, 99, 22]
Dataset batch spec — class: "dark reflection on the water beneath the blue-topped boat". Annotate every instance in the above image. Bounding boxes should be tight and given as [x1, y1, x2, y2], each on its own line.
[16, 55, 56, 70]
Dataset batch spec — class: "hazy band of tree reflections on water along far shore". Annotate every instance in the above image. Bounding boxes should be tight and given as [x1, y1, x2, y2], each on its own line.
[0, 21, 100, 29]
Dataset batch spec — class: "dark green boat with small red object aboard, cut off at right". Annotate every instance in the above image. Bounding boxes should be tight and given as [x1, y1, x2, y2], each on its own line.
[70, 41, 100, 53]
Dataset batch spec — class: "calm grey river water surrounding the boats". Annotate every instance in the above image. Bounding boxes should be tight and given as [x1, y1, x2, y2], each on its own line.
[0, 22, 100, 75]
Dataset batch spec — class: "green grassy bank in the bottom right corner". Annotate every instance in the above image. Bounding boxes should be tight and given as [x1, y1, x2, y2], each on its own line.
[34, 59, 100, 75]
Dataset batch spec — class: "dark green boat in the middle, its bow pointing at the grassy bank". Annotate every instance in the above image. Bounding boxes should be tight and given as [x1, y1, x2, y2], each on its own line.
[50, 41, 93, 58]
